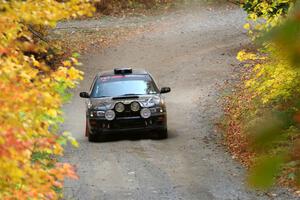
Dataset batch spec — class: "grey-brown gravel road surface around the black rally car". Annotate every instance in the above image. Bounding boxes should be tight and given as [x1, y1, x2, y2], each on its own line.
[60, 5, 298, 200]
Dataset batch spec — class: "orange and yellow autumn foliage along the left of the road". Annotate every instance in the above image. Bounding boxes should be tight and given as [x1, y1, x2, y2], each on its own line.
[0, 0, 94, 200]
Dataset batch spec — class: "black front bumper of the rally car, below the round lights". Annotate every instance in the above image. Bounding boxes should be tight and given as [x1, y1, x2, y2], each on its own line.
[88, 113, 167, 134]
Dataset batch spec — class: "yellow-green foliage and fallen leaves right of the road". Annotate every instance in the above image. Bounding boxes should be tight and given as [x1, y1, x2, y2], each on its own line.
[225, 0, 300, 189]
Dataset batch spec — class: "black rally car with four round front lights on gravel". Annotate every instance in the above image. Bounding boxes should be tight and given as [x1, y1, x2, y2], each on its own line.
[80, 68, 171, 141]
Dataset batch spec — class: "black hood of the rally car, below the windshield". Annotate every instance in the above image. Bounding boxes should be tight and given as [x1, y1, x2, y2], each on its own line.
[88, 95, 161, 110]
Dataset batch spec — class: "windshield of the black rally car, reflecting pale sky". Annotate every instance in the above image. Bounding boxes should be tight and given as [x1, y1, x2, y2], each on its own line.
[91, 75, 158, 98]
